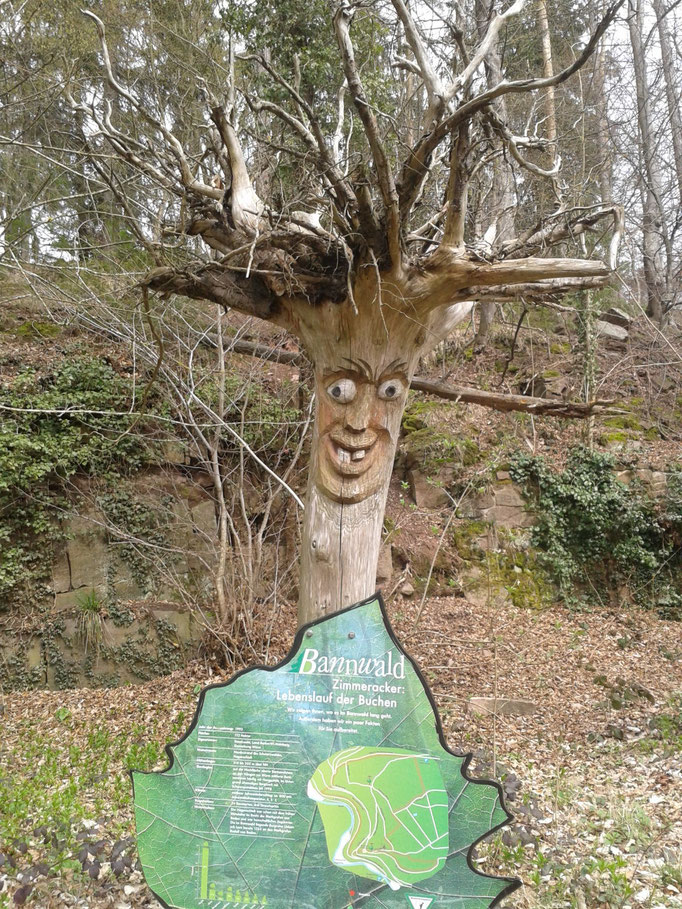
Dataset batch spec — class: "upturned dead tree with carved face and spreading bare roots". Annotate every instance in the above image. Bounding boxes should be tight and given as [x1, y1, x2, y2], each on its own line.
[3, 0, 624, 622]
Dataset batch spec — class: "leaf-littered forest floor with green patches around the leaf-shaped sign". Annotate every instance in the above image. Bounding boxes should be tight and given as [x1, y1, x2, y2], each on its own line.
[0, 597, 682, 909]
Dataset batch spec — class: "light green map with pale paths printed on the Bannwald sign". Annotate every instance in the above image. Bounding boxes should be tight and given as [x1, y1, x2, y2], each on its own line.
[308, 748, 448, 890]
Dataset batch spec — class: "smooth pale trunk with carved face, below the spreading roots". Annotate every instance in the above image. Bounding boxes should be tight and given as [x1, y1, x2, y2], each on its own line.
[294, 266, 470, 624]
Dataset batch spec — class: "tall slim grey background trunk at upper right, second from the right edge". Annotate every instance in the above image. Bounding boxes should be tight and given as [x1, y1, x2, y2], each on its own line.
[628, 0, 666, 322]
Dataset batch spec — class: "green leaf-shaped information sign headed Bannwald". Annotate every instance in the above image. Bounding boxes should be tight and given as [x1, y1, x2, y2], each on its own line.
[134, 596, 518, 909]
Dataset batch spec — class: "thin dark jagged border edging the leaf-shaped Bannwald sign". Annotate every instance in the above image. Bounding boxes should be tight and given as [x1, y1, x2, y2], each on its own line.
[129, 590, 523, 909]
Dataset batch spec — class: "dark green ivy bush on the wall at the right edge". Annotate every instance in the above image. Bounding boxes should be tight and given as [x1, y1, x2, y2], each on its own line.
[510, 448, 682, 619]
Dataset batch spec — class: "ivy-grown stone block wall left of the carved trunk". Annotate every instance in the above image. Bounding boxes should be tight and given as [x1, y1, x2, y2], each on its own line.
[0, 468, 216, 690]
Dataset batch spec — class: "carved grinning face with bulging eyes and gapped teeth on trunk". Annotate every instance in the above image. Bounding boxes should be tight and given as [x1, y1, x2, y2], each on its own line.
[316, 359, 409, 504]
